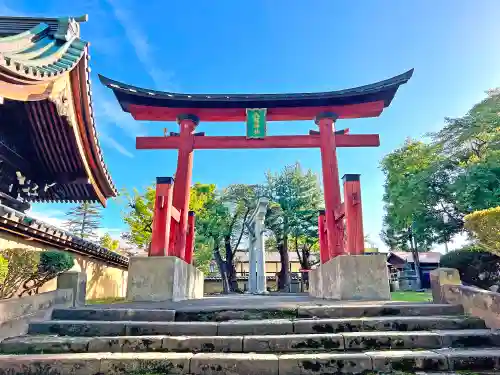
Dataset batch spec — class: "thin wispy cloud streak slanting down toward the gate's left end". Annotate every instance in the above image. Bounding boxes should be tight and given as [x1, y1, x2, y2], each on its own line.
[107, 0, 173, 90]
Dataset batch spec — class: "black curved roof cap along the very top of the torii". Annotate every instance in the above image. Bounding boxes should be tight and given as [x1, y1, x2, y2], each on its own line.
[99, 69, 413, 111]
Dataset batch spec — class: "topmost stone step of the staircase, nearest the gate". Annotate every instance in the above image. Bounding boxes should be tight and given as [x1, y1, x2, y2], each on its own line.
[52, 303, 463, 322]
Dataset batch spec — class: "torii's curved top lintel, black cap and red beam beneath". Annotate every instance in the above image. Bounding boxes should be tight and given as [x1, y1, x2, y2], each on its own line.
[99, 69, 413, 122]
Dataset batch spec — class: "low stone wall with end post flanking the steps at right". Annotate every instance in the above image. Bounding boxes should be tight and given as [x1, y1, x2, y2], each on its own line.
[431, 268, 500, 329]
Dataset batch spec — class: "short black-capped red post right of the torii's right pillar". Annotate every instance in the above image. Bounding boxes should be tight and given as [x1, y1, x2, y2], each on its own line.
[342, 174, 365, 255]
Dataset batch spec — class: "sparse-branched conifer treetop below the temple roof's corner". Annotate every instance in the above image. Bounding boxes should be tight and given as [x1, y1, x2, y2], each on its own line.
[65, 202, 101, 240]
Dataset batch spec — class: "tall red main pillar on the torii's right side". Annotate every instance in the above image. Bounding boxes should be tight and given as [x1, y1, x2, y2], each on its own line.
[315, 112, 344, 259]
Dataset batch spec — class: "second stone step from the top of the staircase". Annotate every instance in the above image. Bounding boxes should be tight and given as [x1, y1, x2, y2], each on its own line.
[25, 316, 485, 336]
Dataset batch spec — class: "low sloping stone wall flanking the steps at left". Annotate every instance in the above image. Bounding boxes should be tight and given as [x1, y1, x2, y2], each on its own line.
[0, 289, 73, 340]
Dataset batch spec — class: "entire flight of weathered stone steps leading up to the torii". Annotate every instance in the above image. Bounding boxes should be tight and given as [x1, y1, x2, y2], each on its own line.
[0, 302, 500, 375]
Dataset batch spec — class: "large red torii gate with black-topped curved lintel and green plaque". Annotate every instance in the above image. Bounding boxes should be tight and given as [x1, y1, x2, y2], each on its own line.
[99, 70, 413, 263]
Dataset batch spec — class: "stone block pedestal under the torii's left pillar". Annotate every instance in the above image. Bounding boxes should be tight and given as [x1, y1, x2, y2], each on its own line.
[127, 257, 204, 302]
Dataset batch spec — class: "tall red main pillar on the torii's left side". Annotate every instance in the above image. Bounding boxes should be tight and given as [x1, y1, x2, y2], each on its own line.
[172, 115, 199, 259]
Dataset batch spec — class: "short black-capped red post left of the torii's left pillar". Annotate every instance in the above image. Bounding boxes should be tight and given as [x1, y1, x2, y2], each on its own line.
[149, 177, 174, 256]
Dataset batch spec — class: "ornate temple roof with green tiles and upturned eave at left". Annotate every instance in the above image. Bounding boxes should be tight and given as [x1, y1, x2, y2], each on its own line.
[0, 17, 117, 205]
